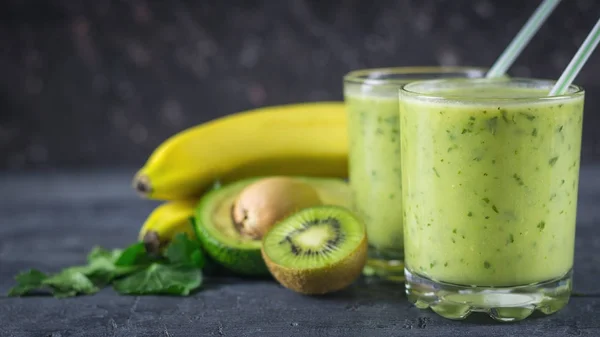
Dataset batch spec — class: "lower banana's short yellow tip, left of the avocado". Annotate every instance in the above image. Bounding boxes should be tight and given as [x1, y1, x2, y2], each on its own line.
[138, 200, 197, 252]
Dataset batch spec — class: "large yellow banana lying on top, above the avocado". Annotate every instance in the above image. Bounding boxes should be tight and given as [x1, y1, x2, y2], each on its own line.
[133, 102, 348, 200]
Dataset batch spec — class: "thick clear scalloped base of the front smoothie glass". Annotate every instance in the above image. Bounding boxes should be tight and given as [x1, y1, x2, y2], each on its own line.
[405, 269, 572, 322]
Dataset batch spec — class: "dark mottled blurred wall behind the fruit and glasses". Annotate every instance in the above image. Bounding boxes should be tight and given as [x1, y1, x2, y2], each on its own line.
[0, 0, 600, 170]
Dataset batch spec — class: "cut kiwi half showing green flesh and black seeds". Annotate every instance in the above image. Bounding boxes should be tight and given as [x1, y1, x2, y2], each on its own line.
[262, 205, 367, 294]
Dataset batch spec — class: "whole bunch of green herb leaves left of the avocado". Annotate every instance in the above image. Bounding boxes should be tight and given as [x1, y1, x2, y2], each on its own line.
[9, 233, 205, 298]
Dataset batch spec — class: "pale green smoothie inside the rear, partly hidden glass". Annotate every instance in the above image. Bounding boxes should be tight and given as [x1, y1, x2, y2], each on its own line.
[345, 91, 403, 253]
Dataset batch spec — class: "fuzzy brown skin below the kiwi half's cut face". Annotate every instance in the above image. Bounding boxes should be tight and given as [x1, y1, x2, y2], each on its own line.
[261, 235, 368, 295]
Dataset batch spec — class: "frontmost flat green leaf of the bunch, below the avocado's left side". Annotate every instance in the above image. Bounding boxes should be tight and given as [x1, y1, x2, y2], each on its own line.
[113, 263, 202, 296]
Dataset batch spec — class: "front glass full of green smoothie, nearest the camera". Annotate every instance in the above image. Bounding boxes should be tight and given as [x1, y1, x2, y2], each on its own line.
[399, 78, 584, 321]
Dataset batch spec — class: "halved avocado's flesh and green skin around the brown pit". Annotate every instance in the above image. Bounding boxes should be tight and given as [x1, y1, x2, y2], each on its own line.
[194, 177, 350, 276]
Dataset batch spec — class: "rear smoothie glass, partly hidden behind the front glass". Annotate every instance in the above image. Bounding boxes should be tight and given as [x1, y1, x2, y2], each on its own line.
[344, 67, 485, 281]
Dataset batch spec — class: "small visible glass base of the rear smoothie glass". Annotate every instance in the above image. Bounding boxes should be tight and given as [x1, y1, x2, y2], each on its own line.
[363, 247, 404, 283]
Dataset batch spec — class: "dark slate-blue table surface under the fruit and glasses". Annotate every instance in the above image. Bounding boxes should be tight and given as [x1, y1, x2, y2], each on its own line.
[0, 166, 600, 337]
